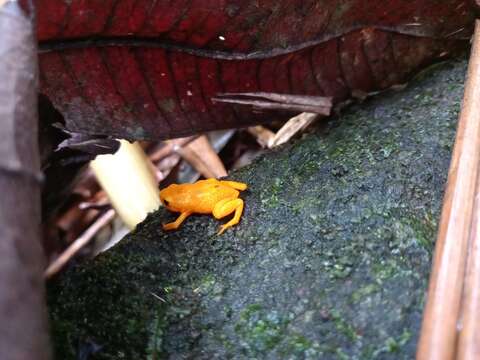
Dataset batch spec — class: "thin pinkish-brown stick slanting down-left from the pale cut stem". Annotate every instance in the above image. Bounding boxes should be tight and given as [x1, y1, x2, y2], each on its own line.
[44, 209, 116, 279]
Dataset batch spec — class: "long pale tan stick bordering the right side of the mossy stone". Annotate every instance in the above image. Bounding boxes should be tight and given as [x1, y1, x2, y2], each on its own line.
[417, 20, 480, 360]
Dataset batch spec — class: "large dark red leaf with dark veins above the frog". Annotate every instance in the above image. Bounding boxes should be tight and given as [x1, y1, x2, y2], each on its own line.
[36, 0, 474, 139]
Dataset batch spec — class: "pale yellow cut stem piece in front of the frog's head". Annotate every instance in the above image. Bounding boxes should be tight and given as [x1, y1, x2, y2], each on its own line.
[90, 140, 161, 229]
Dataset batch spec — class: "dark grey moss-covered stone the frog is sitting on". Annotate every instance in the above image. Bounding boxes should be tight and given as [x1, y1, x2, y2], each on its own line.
[49, 57, 466, 359]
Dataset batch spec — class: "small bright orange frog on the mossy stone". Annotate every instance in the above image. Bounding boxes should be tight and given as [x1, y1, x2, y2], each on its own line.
[160, 179, 247, 235]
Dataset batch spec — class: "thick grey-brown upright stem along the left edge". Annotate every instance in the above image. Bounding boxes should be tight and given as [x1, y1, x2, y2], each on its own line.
[0, 0, 50, 360]
